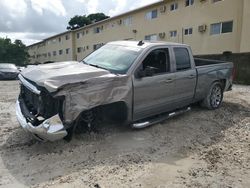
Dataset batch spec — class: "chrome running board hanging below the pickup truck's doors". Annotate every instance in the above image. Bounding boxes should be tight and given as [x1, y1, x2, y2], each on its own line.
[132, 107, 191, 129]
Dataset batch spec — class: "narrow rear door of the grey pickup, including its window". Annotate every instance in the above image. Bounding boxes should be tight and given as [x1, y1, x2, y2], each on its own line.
[173, 47, 197, 108]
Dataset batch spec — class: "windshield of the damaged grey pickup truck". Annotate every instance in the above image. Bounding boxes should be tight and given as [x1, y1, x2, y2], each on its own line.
[82, 44, 141, 74]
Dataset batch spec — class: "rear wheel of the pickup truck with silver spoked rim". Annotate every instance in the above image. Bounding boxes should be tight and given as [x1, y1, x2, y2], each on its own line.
[201, 82, 223, 110]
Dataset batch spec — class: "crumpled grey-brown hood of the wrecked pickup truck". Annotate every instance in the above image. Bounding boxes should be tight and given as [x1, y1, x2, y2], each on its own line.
[21, 61, 110, 92]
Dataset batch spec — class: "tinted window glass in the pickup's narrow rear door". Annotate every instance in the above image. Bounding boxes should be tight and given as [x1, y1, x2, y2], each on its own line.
[174, 48, 191, 71]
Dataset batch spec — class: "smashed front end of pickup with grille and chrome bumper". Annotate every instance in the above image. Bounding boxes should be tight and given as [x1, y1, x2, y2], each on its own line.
[16, 75, 67, 141]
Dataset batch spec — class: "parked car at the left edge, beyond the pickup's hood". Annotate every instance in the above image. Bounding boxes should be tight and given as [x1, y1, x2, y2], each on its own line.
[0, 63, 19, 80]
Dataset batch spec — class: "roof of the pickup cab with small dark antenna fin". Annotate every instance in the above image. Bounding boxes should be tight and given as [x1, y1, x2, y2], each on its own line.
[108, 41, 188, 49]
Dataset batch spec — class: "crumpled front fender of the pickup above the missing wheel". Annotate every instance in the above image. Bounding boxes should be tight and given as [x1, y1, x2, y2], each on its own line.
[55, 74, 132, 124]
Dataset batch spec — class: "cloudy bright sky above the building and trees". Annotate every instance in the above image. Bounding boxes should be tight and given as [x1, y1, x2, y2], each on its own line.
[0, 0, 159, 45]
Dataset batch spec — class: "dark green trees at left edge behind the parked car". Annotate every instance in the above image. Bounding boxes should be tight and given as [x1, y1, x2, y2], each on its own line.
[0, 38, 29, 66]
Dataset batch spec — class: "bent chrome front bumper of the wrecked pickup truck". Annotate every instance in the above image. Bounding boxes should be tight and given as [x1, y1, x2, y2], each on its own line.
[16, 100, 68, 142]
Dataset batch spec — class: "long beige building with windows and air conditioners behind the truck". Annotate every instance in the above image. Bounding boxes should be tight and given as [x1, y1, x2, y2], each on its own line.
[28, 0, 250, 63]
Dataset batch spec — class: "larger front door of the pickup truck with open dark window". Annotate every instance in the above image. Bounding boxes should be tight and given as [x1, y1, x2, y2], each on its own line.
[133, 48, 175, 120]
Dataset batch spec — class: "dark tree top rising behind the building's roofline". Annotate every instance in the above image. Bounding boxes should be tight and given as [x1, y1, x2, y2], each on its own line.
[67, 13, 109, 30]
